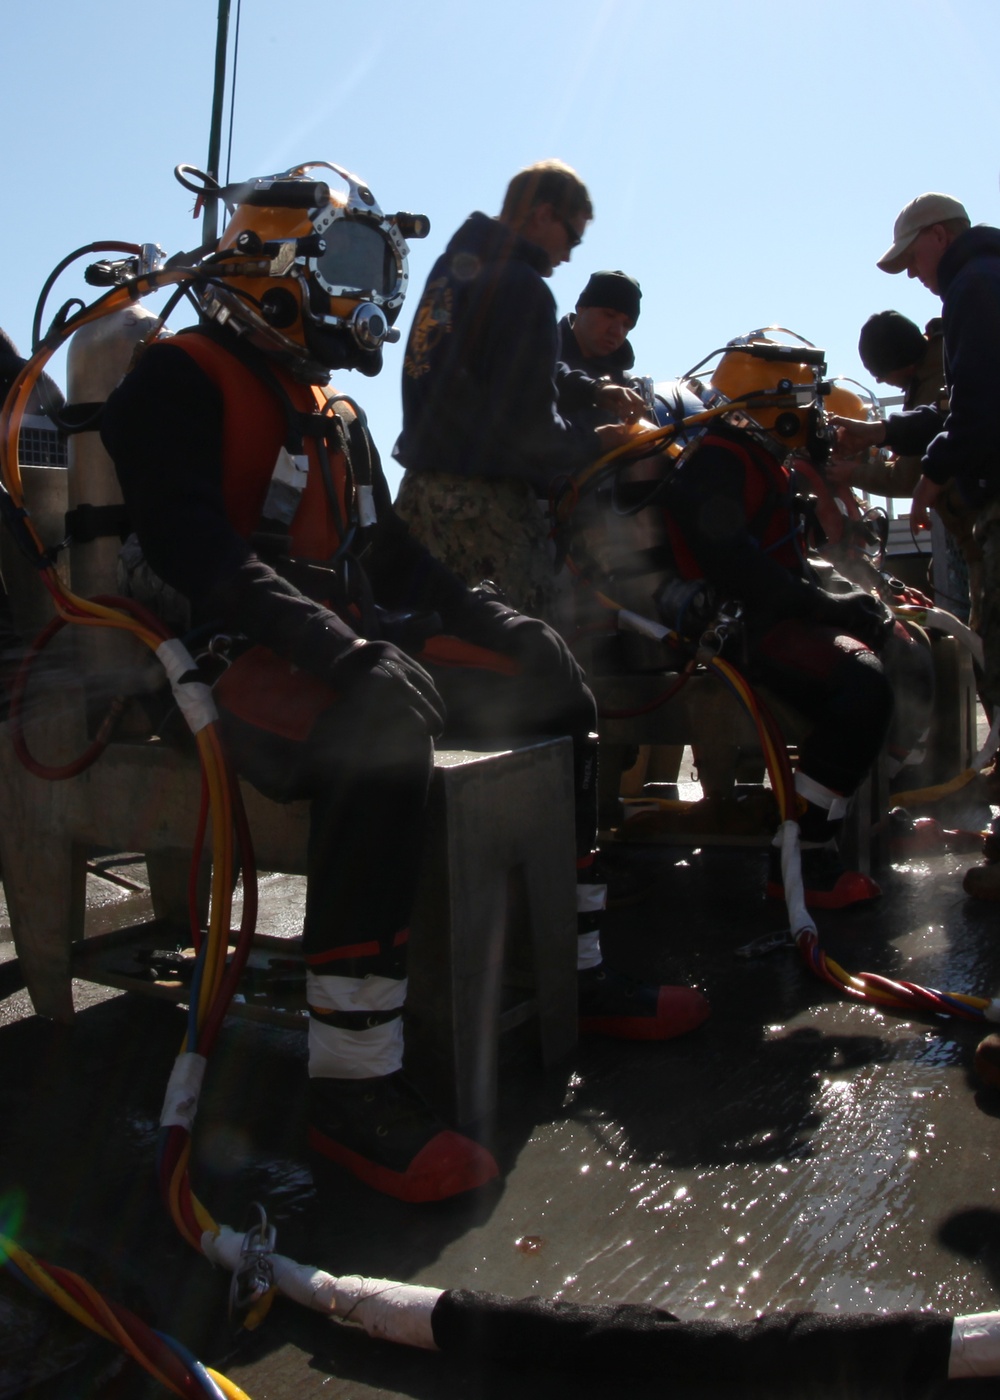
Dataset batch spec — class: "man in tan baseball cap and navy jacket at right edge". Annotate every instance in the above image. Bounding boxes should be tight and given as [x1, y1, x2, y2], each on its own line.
[838, 193, 1000, 900]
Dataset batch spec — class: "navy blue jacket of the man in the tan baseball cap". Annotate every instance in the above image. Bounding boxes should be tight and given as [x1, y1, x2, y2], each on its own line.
[885, 224, 1000, 507]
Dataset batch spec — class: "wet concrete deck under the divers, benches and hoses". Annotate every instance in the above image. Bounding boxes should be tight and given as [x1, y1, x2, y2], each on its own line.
[0, 772, 1000, 1400]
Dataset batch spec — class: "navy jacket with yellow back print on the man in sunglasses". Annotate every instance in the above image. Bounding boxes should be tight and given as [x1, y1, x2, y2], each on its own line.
[394, 213, 601, 493]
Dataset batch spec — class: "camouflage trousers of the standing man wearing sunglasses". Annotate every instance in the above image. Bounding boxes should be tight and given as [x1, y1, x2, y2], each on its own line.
[395, 472, 556, 619]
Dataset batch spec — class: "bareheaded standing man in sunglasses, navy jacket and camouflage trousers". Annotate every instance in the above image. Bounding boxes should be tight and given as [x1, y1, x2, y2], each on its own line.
[394, 160, 643, 616]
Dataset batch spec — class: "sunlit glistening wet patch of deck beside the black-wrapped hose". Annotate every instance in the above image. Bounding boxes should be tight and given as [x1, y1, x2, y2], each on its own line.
[424, 1040, 1000, 1316]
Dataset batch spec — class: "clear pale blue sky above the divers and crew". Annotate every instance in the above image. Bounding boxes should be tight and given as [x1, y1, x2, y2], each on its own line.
[0, 0, 1000, 495]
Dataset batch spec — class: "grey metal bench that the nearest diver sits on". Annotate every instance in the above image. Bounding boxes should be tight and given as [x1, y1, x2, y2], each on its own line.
[0, 706, 577, 1123]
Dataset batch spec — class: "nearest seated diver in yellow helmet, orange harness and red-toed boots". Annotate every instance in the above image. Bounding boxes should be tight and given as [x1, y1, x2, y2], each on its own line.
[102, 153, 707, 1201]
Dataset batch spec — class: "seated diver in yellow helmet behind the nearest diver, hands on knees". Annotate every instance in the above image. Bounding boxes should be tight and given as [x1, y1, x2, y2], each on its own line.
[661, 342, 906, 909]
